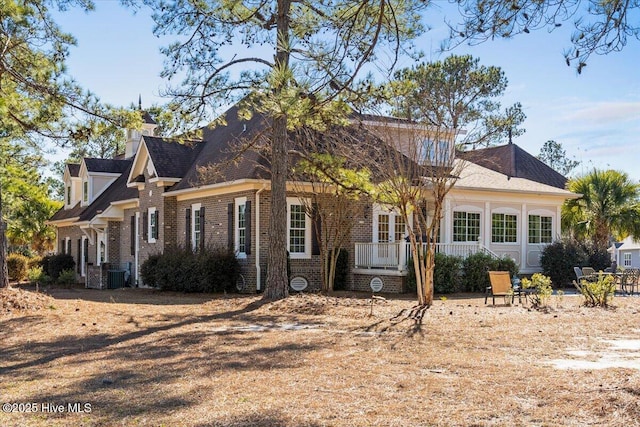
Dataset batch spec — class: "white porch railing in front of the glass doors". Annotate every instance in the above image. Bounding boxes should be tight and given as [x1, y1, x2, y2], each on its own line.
[355, 242, 498, 270]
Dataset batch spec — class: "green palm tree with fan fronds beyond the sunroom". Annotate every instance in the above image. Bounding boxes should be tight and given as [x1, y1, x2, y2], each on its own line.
[562, 169, 640, 248]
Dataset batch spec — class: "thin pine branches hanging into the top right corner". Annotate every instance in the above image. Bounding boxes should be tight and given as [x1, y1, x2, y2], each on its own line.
[444, 0, 640, 74]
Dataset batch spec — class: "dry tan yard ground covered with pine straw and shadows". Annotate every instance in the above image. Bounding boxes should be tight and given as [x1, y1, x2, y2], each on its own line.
[0, 289, 640, 426]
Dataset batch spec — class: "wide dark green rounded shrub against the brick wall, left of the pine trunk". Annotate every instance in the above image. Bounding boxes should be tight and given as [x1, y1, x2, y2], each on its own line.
[140, 248, 240, 292]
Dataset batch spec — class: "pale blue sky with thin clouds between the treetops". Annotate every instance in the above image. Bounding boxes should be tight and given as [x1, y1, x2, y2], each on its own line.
[56, 0, 640, 181]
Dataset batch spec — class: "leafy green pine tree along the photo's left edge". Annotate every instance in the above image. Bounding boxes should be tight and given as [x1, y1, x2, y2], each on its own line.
[0, 0, 142, 287]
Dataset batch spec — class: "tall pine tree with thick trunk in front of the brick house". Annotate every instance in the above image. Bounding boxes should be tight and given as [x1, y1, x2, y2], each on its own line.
[130, 0, 426, 299]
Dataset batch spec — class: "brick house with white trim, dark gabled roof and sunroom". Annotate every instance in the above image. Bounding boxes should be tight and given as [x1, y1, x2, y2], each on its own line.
[50, 107, 576, 292]
